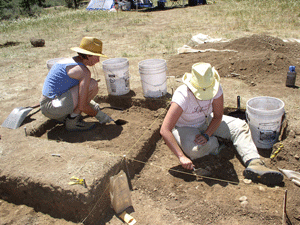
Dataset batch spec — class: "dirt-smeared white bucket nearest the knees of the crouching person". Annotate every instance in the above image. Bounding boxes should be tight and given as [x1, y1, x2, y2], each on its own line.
[102, 58, 130, 95]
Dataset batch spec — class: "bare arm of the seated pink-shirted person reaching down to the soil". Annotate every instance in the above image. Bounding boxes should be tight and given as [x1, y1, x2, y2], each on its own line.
[160, 102, 194, 170]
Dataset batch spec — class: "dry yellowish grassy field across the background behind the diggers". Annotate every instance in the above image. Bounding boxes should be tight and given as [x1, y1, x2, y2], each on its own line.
[0, 0, 300, 81]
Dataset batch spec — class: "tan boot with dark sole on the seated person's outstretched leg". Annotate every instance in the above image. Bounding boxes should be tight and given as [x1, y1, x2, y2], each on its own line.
[244, 159, 283, 185]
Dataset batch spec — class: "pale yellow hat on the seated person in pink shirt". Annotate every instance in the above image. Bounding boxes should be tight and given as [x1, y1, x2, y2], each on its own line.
[182, 62, 220, 100]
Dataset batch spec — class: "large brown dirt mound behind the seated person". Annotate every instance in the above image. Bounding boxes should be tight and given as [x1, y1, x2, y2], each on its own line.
[168, 35, 300, 85]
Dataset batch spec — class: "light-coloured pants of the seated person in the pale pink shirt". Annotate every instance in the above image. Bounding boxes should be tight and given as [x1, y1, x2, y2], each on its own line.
[172, 115, 260, 163]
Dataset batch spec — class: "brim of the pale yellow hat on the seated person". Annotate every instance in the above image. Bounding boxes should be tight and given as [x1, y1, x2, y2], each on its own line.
[182, 71, 220, 101]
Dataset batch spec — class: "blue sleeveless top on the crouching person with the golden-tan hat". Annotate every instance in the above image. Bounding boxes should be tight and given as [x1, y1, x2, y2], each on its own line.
[43, 63, 84, 99]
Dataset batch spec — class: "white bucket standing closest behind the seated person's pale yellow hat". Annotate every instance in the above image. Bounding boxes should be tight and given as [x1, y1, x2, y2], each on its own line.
[139, 59, 167, 98]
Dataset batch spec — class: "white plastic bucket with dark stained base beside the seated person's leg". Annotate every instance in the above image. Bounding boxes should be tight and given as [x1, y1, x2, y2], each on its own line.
[246, 97, 285, 149]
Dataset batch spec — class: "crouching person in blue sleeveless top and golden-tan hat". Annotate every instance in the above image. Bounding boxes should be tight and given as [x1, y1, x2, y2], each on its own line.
[40, 37, 113, 131]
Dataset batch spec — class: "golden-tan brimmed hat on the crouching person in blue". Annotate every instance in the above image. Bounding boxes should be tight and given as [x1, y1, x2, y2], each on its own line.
[71, 37, 107, 57]
